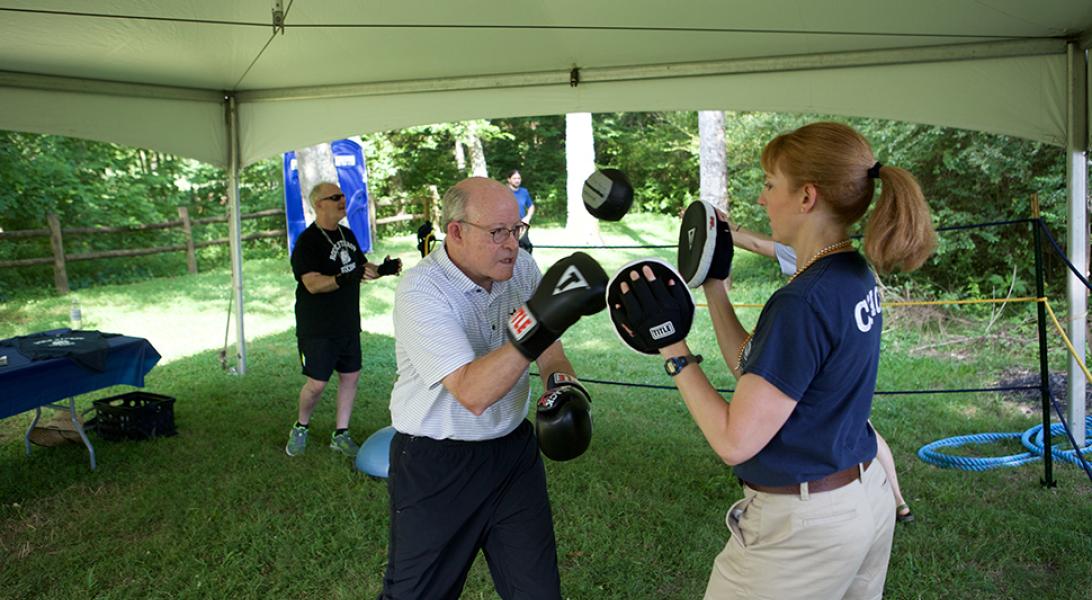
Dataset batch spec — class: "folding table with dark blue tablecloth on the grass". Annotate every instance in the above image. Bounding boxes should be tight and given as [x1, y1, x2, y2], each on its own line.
[0, 329, 159, 470]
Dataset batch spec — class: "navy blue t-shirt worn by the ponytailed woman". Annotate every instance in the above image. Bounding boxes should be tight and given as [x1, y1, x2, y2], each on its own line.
[735, 252, 883, 485]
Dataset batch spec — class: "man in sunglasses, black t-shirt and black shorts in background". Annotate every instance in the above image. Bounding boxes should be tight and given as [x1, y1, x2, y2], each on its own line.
[285, 183, 402, 457]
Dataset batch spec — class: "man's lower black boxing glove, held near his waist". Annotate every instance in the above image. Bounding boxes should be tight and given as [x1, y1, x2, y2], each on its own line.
[535, 373, 592, 460]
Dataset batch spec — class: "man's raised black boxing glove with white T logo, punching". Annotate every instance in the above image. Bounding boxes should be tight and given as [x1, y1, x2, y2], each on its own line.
[508, 252, 607, 361]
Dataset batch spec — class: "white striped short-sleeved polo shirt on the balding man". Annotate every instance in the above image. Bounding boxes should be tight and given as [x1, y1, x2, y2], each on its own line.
[391, 247, 542, 440]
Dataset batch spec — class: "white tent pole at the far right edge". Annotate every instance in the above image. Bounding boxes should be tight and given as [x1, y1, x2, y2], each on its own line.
[1070, 43, 1089, 446]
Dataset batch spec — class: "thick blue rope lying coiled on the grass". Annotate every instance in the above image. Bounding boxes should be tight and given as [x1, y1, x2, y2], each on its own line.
[917, 415, 1092, 471]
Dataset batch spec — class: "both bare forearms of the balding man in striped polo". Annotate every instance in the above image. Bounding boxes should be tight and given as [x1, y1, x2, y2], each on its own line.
[442, 341, 572, 415]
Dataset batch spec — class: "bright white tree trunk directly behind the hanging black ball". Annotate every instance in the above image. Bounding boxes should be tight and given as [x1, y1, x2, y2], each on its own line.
[565, 113, 603, 244]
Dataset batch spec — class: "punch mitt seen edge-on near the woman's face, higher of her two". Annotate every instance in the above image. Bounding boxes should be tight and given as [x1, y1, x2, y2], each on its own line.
[678, 200, 735, 287]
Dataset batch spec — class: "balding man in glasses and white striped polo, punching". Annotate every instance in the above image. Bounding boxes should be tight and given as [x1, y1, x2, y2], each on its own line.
[380, 177, 606, 599]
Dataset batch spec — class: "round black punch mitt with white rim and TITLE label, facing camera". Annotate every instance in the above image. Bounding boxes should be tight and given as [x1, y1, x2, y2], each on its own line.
[607, 258, 695, 354]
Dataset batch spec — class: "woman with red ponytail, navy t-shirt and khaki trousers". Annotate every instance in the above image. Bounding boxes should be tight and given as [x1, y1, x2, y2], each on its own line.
[615, 122, 936, 599]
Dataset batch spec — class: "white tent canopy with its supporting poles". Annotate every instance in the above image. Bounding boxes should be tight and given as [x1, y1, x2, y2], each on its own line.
[0, 0, 1092, 437]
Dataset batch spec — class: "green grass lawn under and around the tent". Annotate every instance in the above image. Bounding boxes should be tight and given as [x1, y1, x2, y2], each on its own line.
[0, 215, 1092, 599]
